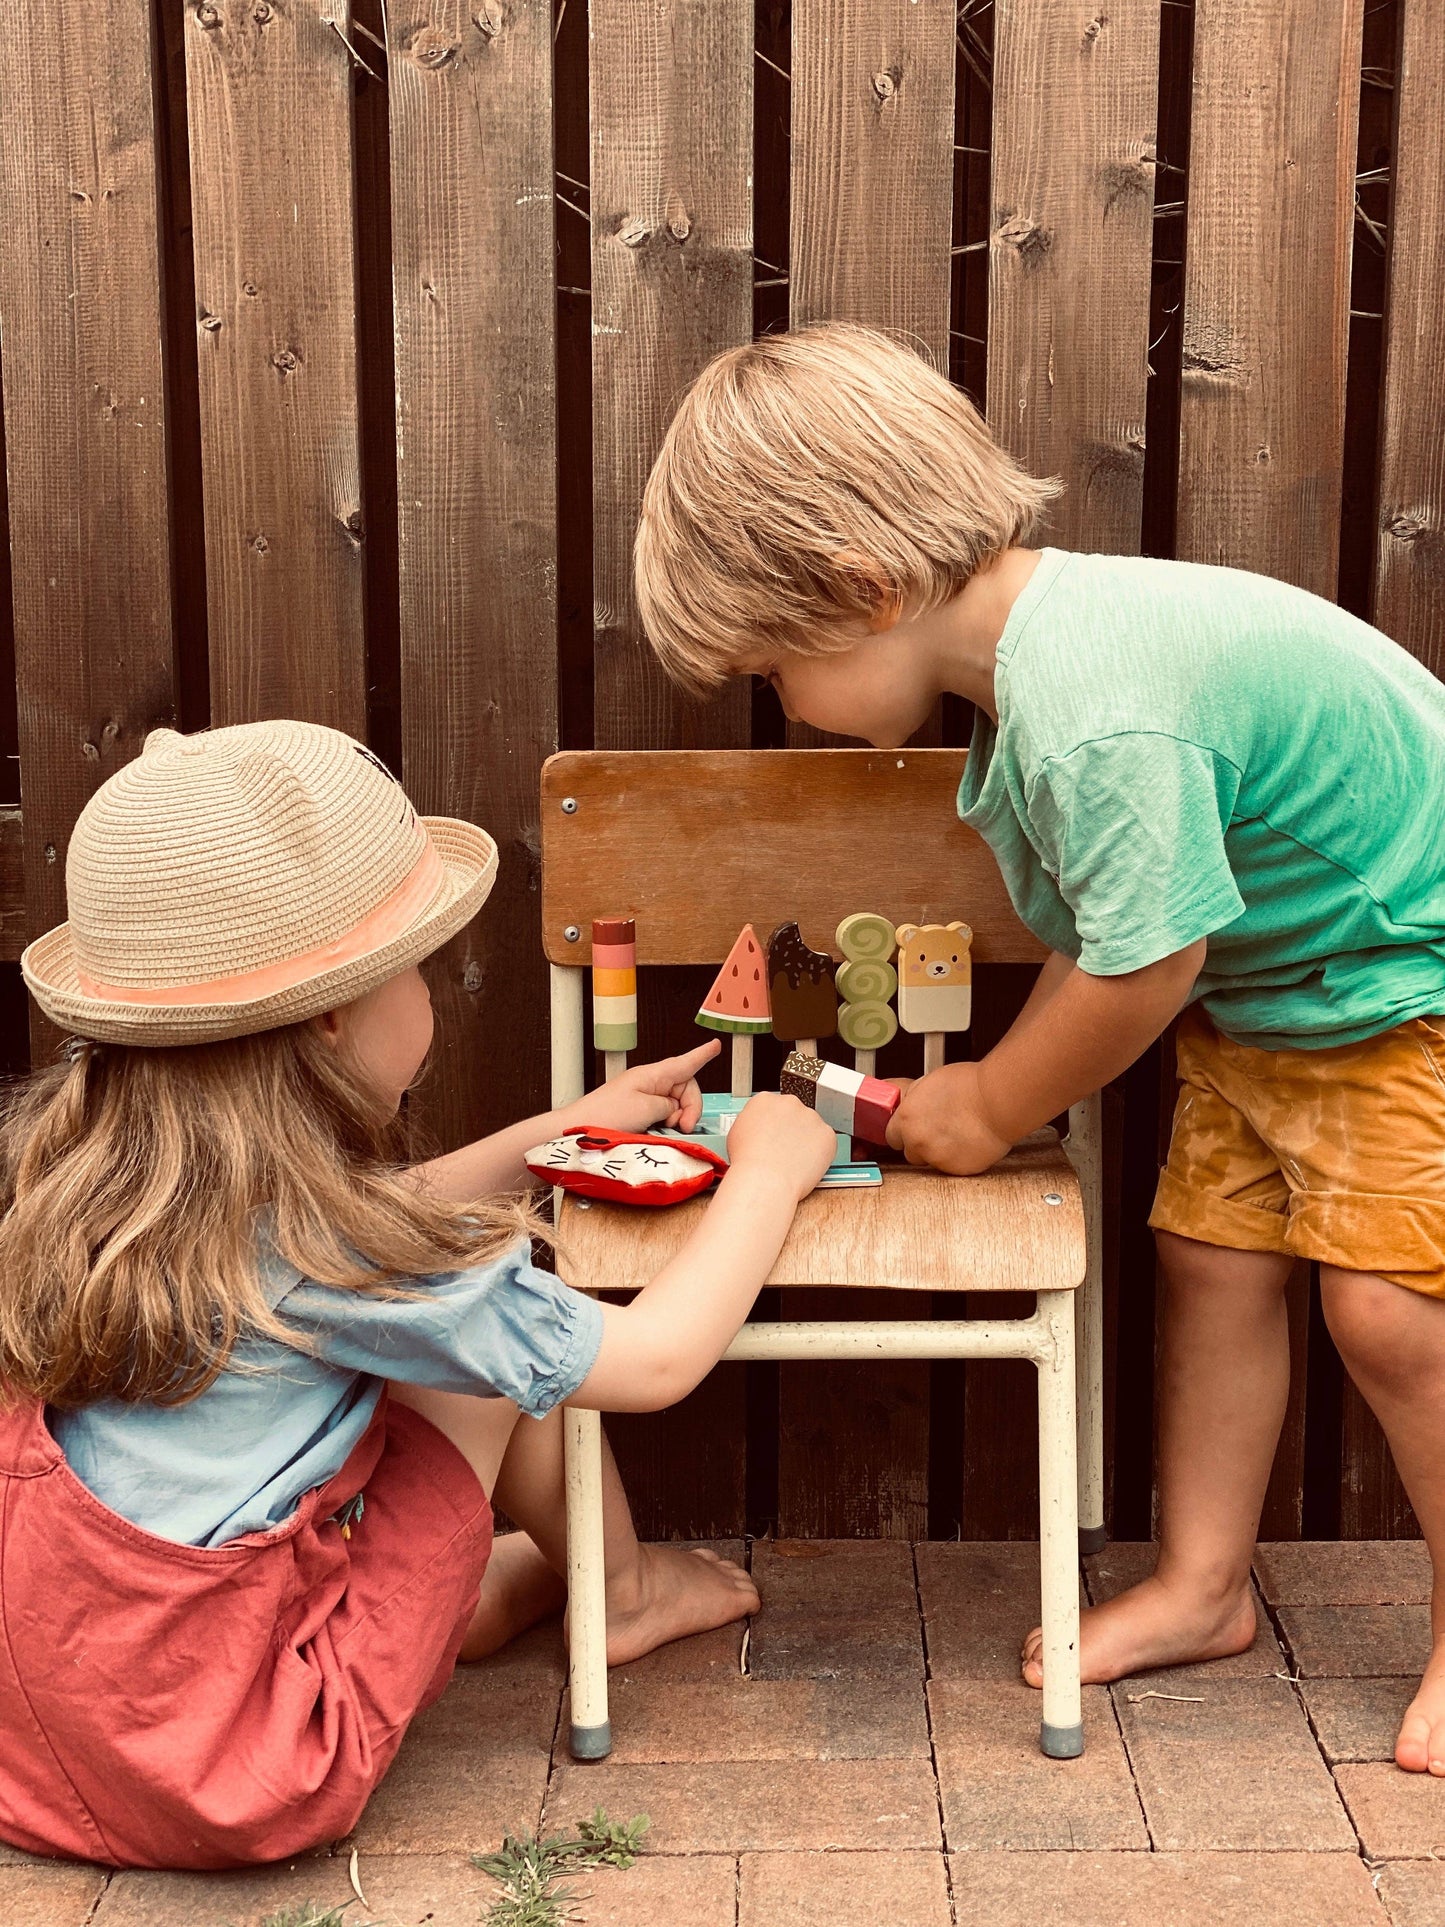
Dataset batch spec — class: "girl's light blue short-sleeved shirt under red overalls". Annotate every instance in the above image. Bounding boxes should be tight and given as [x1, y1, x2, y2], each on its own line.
[48, 1243, 603, 1545]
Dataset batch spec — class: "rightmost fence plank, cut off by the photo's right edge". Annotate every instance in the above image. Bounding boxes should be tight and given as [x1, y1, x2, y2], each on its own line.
[1374, 0, 1445, 676]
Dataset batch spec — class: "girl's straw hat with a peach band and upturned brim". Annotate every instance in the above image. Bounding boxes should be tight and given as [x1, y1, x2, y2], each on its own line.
[21, 723, 497, 1044]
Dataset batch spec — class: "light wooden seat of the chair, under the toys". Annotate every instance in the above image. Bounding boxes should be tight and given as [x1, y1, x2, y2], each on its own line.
[557, 1131, 1087, 1291]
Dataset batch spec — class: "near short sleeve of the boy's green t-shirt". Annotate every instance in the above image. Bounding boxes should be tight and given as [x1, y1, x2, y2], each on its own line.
[1027, 730, 1245, 977]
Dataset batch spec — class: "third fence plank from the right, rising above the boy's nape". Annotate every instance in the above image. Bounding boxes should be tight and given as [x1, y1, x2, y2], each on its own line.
[988, 0, 1160, 555]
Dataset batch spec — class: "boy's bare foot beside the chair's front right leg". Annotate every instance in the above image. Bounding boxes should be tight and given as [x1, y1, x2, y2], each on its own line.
[1021, 1576, 1263, 1695]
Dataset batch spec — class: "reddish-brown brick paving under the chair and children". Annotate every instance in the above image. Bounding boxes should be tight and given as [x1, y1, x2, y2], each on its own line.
[11, 1542, 1445, 1927]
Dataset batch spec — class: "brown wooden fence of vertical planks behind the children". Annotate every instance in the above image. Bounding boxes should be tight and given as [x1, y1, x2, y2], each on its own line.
[0, 0, 1445, 1538]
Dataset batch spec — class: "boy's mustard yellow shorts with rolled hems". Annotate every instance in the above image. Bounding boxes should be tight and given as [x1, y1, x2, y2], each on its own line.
[1148, 1008, 1445, 1299]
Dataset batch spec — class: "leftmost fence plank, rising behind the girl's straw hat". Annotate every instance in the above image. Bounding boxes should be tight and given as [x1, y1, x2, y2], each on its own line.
[0, 0, 173, 1044]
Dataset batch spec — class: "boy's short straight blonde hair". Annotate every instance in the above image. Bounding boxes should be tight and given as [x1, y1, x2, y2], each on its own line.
[636, 322, 1062, 694]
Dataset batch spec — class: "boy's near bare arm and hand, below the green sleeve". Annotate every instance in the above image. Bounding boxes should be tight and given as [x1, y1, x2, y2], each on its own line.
[888, 938, 1204, 1174]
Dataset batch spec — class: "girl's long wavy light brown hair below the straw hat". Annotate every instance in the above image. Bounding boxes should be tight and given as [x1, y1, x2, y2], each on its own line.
[0, 1023, 545, 1407]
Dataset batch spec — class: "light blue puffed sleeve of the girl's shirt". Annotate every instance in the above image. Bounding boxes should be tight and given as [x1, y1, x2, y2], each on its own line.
[277, 1243, 603, 1418]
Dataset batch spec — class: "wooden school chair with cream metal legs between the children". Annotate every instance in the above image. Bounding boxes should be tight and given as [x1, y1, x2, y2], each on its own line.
[541, 750, 1104, 1759]
